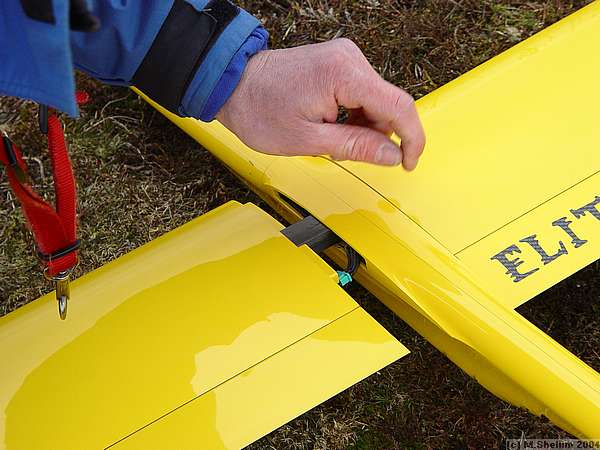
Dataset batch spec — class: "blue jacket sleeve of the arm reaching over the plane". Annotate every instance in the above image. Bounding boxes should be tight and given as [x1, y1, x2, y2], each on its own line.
[71, 0, 268, 121]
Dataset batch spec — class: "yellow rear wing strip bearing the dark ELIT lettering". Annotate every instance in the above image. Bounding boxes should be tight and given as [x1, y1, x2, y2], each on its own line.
[457, 173, 600, 308]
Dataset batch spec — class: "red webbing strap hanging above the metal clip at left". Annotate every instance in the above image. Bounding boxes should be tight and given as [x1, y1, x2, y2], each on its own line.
[0, 99, 79, 276]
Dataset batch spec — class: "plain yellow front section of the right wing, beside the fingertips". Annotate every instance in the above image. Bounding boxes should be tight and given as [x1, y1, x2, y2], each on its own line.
[341, 1, 600, 253]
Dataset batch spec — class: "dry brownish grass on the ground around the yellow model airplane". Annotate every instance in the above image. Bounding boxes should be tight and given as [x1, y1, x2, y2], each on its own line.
[0, 0, 600, 450]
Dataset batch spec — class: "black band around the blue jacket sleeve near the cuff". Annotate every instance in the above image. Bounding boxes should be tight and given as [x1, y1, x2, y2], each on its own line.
[131, 0, 239, 114]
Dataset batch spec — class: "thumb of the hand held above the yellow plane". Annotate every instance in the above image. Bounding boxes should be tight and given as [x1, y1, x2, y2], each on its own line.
[315, 123, 402, 166]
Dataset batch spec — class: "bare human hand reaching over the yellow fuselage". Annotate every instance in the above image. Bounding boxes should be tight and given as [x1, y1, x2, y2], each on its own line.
[217, 39, 425, 170]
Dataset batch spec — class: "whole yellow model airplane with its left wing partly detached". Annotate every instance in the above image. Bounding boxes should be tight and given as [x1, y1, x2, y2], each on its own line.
[0, 2, 600, 450]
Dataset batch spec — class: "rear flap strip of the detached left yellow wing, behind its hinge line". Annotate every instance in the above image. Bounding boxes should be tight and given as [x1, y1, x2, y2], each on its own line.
[112, 308, 408, 450]
